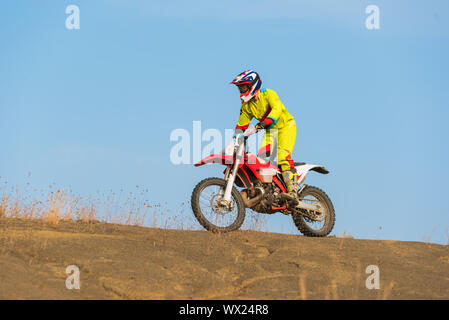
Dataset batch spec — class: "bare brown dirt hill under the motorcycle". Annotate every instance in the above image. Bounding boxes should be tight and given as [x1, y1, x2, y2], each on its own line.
[0, 218, 449, 299]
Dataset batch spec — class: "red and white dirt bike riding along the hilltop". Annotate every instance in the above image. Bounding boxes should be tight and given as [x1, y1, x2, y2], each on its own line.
[191, 126, 335, 237]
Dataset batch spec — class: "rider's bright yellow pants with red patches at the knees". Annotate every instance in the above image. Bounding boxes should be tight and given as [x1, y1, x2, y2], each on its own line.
[259, 119, 296, 171]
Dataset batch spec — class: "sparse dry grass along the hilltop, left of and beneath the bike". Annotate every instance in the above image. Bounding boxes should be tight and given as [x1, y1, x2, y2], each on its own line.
[0, 177, 268, 231]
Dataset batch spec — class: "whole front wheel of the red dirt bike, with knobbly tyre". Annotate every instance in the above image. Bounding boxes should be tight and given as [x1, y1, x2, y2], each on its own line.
[191, 178, 246, 232]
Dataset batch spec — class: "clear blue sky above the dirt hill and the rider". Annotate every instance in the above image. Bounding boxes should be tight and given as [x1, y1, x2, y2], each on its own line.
[0, 0, 449, 243]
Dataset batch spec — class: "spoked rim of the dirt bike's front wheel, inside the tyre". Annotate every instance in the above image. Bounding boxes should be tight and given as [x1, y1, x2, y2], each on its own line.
[198, 185, 238, 228]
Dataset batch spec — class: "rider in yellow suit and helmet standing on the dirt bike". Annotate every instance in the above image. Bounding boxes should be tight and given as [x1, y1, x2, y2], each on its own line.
[231, 70, 297, 200]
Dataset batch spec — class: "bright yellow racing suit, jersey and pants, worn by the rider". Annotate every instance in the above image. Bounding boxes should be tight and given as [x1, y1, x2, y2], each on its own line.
[235, 89, 296, 171]
